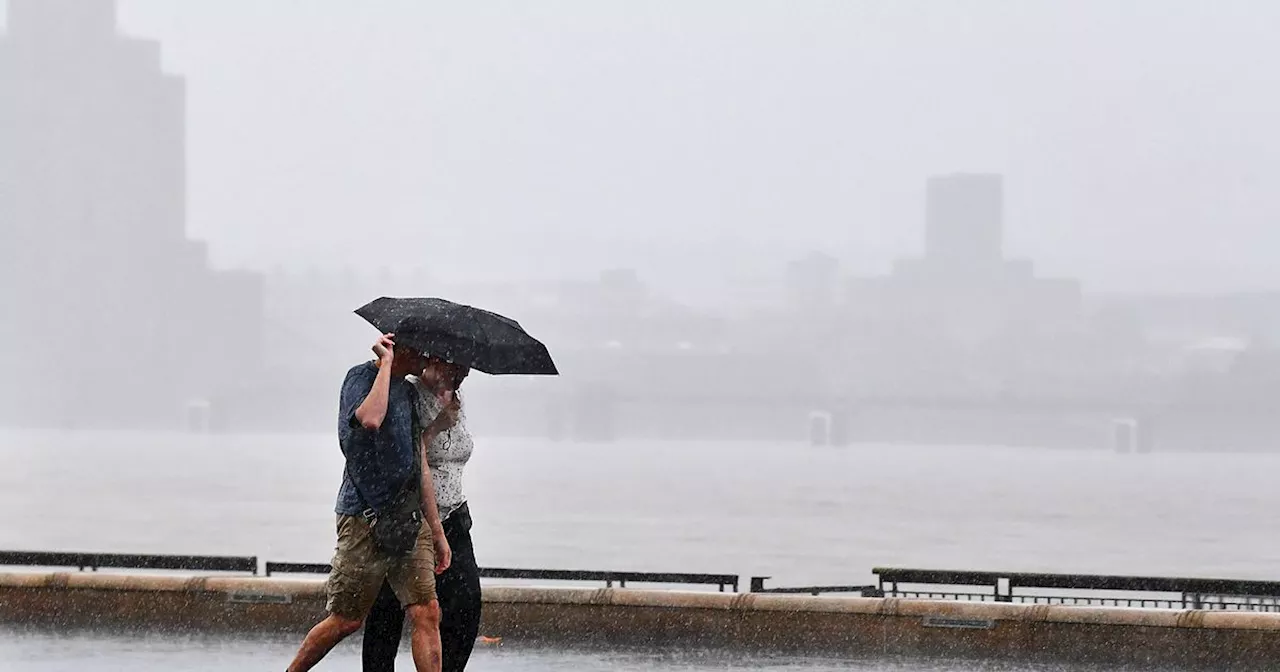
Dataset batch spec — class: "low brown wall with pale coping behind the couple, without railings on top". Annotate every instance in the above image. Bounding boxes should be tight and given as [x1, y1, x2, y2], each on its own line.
[0, 573, 1280, 671]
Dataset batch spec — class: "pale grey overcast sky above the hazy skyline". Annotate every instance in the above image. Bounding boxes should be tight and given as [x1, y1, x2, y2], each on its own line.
[7, 0, 1280, 291]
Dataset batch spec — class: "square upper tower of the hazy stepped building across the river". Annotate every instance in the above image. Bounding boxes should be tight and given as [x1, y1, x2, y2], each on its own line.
[925, 173, 1005, 269]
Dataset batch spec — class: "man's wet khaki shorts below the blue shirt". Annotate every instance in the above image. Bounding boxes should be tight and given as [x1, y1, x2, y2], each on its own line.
[325, 515, 435, 620]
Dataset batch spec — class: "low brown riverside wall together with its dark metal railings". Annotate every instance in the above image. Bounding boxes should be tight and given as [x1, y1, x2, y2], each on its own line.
[0, 553, 1280, 671]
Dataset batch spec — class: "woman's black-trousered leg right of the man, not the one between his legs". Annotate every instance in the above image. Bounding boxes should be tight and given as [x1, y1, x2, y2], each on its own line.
[435, 509, 481, 672]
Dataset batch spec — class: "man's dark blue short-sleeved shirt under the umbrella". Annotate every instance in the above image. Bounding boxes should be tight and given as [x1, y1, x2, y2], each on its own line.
[334, 362, 417, 516]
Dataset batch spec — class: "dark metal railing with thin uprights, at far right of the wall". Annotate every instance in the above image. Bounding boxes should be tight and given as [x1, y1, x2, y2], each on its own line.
[873, 567, 1280, 612]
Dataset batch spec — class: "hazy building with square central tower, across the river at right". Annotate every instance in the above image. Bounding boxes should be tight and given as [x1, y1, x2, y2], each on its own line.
[845, 174, 1083, 393]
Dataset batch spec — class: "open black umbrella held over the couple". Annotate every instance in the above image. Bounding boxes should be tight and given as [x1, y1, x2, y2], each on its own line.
[356, 297, 559, 375]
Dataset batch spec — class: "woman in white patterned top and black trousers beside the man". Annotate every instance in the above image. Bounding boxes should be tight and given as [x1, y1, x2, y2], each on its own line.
[364, 357, 481, 672]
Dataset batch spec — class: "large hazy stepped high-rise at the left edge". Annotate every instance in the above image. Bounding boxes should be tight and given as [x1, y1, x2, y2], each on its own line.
[0, 0, 262, 425]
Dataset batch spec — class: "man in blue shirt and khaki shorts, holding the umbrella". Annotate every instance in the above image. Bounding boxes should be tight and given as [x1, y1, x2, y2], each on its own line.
[289, 334, 449, 672]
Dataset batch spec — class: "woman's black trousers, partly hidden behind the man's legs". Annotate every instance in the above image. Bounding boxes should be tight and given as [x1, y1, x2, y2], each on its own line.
[364, 504, 480, 672]
